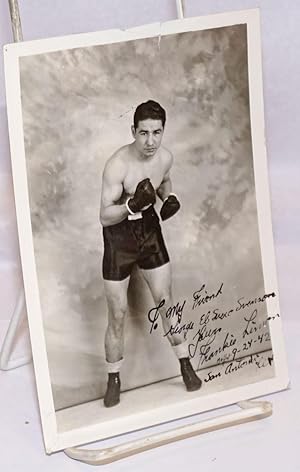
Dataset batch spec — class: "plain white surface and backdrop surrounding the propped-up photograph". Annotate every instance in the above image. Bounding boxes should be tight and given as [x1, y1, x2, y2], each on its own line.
[0, 0, 300, 472]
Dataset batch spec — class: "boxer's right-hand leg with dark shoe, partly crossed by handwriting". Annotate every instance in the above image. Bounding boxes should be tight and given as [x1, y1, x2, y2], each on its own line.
[142, 262, 202, 392]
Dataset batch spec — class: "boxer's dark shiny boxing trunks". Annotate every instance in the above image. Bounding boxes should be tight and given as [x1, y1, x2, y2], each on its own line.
[102, 206, 169, 280]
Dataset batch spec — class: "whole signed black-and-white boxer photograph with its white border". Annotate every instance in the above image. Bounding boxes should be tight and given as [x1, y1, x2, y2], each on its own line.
[4, 10, 288, 453]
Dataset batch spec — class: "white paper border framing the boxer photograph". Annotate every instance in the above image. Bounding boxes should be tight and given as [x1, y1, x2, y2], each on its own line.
[4, 9, 289, 453]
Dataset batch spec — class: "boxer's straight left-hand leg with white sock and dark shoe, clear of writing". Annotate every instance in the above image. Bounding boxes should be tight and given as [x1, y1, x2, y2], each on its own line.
[104, 277, 129, 407]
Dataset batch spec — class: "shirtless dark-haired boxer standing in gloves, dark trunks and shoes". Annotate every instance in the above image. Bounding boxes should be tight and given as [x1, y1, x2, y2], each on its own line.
[100, 100, 201, 407]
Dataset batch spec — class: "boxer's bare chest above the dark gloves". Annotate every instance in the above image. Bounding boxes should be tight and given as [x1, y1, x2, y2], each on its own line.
[123, 159, 165, 196]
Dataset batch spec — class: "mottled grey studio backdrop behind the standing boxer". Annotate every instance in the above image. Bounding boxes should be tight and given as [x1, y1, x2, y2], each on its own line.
[20, 25, 270, 409]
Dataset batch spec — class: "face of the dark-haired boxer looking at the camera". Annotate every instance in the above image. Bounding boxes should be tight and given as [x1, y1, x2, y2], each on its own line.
[132, 118, 164, 158]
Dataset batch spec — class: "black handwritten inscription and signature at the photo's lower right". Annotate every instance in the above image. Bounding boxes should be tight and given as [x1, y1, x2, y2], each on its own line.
[148, 282, 280, 382]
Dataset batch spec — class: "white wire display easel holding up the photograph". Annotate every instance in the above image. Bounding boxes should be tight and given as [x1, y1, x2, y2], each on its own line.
[0, 0, 272, 465]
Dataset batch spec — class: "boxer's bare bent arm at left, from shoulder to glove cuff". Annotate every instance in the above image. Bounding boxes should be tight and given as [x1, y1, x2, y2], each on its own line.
[100, 158, 128, 226]
